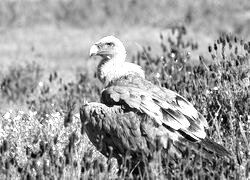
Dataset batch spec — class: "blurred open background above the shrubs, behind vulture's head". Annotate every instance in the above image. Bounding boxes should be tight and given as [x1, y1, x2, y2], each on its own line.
[0, 0, 250, 76]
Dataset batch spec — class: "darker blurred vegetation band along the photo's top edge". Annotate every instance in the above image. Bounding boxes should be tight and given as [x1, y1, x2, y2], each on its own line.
[0, 0, 249, 29]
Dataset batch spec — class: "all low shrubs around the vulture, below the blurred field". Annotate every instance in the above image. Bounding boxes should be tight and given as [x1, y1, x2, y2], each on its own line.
[0, 23, 250, 179]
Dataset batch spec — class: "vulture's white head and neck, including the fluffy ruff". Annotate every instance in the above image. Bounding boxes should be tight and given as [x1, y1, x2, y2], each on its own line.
[89, 36, 145, 86]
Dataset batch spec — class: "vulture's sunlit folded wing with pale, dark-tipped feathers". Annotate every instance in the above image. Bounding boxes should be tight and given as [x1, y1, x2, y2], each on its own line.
[101, 75, 208, 140]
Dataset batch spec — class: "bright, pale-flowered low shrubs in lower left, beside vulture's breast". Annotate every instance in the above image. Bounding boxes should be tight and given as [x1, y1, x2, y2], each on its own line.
[0, 111, 117, 179]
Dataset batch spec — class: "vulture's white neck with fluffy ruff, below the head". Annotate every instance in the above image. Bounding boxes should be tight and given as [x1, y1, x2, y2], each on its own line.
[97, 54, 145, 86]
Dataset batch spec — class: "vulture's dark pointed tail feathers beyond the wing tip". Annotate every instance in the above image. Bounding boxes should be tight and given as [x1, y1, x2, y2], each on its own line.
[200, 137, 231, 157]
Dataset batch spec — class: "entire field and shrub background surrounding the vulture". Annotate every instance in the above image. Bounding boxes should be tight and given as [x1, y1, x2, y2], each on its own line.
[0, 0, 250, 179]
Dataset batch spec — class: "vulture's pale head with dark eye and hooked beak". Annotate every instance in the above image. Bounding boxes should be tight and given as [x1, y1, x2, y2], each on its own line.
[89, 36, 126, 61]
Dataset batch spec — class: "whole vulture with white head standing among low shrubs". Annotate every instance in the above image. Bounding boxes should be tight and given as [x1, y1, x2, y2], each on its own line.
[80, 36, 230, 174]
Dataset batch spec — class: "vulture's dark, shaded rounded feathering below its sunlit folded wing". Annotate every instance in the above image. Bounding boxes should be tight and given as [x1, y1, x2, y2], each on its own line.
[80, 102, 154, 158]
